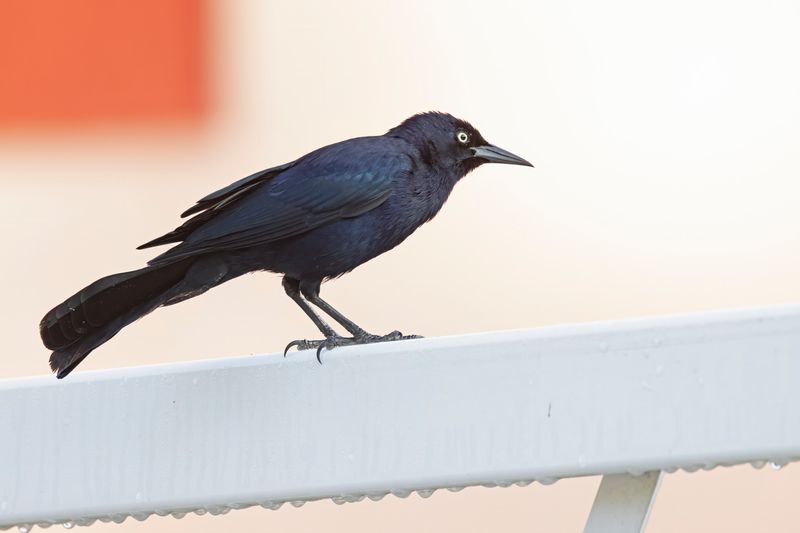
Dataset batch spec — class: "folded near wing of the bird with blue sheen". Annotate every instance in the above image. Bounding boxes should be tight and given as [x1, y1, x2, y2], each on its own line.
[150, 140, 410, 264]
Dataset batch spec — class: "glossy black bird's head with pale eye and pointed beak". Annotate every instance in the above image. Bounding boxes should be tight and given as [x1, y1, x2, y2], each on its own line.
[387, 112, 533, 177]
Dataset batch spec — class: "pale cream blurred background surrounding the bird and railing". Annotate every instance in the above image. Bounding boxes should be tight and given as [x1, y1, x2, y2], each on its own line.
[0, 0, 800, 532]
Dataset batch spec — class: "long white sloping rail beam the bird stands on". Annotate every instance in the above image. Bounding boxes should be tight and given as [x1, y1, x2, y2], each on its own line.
[0, 306, 800, 527]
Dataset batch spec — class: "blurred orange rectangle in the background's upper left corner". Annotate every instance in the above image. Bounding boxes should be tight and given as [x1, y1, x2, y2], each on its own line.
[0, 0, 208, 123]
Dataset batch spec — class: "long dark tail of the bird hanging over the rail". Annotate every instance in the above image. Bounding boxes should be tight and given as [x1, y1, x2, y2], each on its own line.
[39, 258, 224, 379]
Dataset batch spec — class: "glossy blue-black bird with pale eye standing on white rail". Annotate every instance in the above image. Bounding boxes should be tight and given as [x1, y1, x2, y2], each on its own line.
[39, 113, 533, 378]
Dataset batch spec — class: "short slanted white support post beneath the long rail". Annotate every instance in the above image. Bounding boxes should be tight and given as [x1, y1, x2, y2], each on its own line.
[583, 472, 661, 533]
